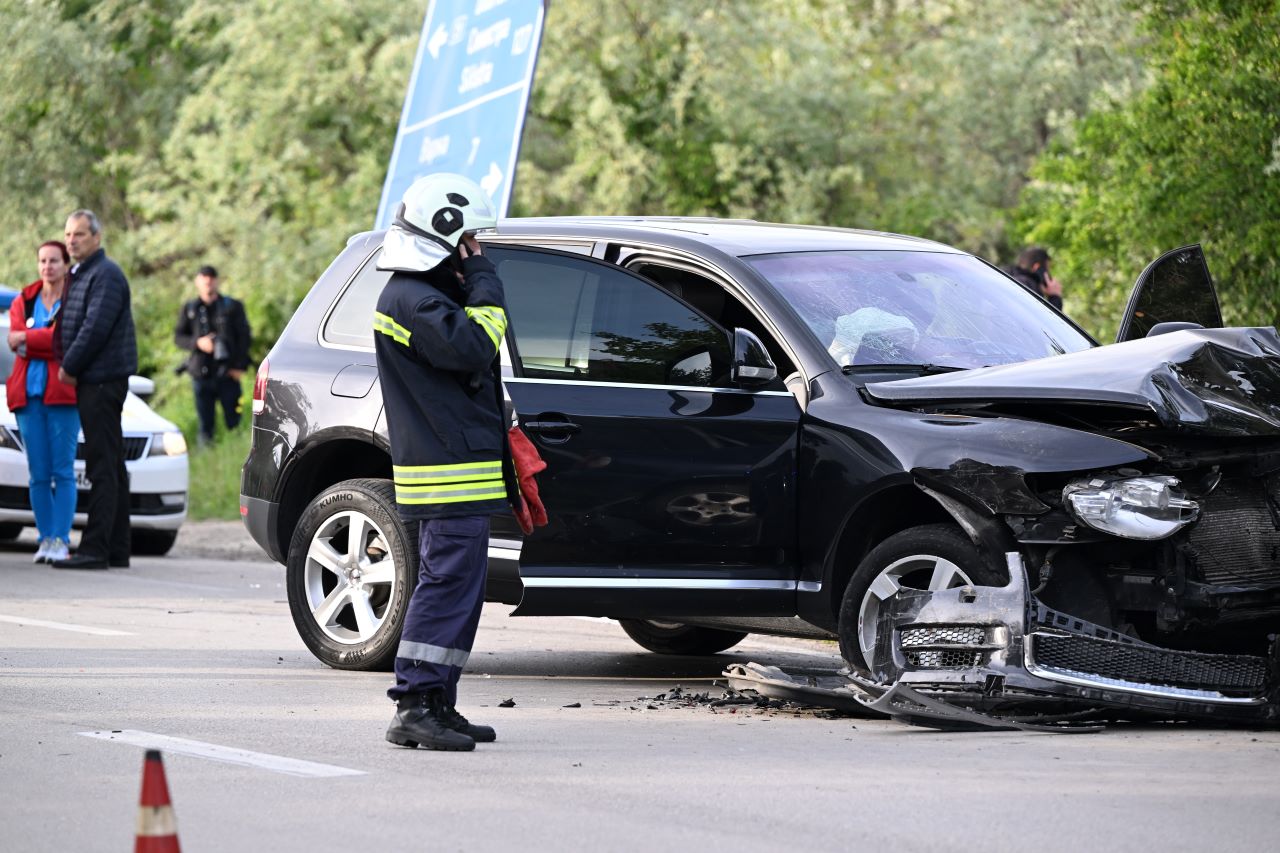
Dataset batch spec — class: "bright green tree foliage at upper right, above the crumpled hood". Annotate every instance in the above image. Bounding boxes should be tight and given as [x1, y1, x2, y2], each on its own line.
[1018, 0, 1280, 338]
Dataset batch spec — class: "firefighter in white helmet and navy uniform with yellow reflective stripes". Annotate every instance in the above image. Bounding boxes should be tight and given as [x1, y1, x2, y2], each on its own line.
[374, 174, 518, 752]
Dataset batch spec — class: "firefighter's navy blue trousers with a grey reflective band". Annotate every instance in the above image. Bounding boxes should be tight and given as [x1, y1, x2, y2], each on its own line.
[387, 515, 489, 706]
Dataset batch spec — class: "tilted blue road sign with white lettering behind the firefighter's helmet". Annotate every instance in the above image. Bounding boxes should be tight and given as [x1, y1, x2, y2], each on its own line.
[374, 0, 543, 228]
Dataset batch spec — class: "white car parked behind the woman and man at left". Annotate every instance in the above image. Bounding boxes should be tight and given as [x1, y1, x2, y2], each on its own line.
[0, 311, 187, 555]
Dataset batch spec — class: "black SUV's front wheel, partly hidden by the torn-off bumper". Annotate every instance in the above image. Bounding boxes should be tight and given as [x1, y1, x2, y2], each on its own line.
[837, 524, 1009, 676]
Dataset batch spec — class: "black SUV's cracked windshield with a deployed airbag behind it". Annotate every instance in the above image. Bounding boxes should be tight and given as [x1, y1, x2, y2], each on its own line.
[745, 251, 1093, 368]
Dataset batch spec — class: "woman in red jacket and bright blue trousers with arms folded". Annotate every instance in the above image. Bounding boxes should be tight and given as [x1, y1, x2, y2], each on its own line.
[5, 240, 79, 562]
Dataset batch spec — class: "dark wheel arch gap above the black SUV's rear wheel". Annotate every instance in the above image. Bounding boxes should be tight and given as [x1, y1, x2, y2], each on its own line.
[275, 433, 392, 558]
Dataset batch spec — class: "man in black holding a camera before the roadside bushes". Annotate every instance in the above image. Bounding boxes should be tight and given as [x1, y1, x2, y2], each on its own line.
[173, 264, 251, 444]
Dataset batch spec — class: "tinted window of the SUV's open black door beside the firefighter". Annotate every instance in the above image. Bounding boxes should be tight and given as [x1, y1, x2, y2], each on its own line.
[488, 242, 730, 386]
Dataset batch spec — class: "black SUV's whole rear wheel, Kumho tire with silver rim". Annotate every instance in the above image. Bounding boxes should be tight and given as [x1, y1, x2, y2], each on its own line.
[285, 479, 419, 671]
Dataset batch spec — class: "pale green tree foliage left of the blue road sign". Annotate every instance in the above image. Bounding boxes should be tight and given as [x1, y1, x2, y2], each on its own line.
[0, 0, 426, 397]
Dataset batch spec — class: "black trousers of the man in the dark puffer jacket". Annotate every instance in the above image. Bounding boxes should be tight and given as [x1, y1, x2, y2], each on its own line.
[76, 379, 129, 562]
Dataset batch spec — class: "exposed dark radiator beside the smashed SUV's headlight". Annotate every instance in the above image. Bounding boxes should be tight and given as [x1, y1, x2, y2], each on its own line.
[1189, 476, 1280, 584]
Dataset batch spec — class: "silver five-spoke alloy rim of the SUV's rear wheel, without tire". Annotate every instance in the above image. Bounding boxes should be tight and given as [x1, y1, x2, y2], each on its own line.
[303, 510, 396, 646]
